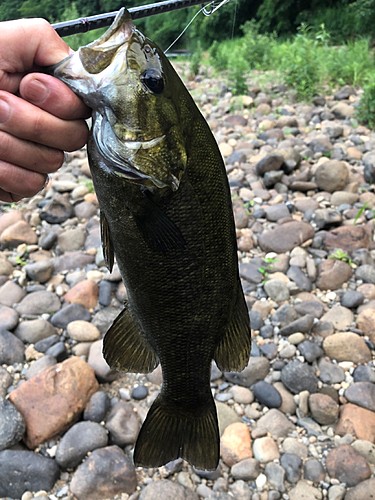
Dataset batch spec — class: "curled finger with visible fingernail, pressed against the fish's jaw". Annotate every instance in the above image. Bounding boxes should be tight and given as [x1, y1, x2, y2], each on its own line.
[20, 73, 91, 120]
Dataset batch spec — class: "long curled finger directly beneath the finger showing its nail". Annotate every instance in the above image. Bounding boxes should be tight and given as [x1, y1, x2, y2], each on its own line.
[0, 91, 88, 151]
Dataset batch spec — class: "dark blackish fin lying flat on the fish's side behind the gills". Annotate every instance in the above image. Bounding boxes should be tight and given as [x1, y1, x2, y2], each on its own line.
[134, 194, 185, 254]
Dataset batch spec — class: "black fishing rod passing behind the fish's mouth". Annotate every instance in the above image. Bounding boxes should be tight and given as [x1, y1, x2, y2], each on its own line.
[52, 0, 213, 37]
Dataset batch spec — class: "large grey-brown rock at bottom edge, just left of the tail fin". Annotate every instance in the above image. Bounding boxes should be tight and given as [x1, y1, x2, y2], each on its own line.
[70, 446, 137, 500]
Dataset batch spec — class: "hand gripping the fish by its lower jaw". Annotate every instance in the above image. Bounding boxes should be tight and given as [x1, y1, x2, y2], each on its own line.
[0, 19, 90, 202]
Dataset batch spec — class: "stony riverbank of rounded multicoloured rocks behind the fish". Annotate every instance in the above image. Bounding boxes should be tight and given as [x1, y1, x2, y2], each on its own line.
[0, 64, 375, 500]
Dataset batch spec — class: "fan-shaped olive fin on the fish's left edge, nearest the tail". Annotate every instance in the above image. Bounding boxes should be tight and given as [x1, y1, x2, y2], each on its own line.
[103, 304, 159, 373]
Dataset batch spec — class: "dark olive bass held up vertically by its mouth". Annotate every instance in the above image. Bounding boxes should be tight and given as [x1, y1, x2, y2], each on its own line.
[53, 8, 251, 470]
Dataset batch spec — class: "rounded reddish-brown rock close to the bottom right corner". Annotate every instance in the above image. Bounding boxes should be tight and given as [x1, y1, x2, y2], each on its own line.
[326, 444, 371, 487]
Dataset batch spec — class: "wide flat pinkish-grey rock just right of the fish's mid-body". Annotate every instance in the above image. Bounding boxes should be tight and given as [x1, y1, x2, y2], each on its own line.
[258, 221, 315, 253]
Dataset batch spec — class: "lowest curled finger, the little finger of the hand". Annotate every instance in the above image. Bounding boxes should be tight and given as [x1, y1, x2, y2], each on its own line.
[0, 160, 47, 201]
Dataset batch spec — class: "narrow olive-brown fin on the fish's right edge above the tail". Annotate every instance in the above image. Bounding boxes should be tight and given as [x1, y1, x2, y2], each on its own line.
[214, 281, 251, 372]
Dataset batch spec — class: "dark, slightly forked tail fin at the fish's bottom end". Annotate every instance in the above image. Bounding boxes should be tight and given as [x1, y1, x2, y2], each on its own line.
[134, 394, 220, 470]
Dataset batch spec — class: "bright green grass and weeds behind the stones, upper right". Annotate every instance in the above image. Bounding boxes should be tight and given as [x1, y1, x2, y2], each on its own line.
[210, 22, 375, 106]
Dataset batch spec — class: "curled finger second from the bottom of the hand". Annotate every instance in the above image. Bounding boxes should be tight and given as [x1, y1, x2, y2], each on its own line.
[0, 131, 64, 174]
